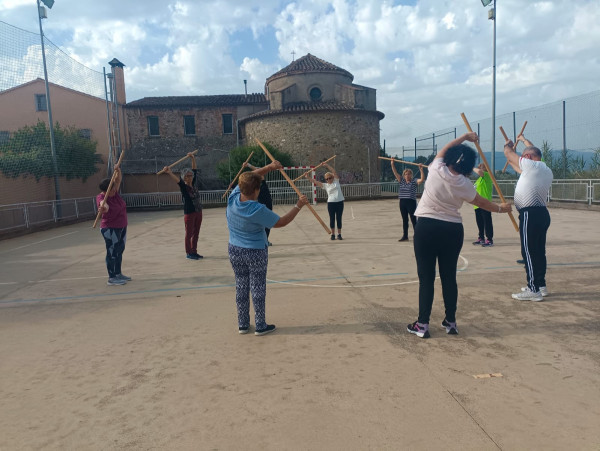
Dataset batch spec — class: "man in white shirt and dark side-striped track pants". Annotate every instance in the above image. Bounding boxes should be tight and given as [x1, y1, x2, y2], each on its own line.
[504, 135, 553, 301]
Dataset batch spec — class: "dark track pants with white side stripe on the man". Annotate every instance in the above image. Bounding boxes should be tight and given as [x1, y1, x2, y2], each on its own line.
[519, 207, 550, 293]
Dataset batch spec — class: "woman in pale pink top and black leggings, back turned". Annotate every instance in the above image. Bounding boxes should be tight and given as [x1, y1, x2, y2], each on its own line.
[407, 133, 511, 338]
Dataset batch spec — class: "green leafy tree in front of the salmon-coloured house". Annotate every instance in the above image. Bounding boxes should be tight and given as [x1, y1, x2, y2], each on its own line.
[0, 121, 102, 181]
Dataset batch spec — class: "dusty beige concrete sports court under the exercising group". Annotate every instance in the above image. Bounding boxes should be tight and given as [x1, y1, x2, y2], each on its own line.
[0, 200, 600, 450]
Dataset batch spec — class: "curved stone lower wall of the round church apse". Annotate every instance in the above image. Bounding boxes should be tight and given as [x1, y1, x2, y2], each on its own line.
[243, 111, 381, 183]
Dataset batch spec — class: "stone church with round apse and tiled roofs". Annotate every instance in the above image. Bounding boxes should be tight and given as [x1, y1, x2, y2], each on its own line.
[123, 53, 384, 192]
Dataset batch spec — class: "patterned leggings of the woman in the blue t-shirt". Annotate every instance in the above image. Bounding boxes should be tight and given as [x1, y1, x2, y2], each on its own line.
[229, 244, 269, 329]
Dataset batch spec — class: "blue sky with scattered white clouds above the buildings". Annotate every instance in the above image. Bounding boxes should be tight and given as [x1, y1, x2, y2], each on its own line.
[0, 0, 600, 154]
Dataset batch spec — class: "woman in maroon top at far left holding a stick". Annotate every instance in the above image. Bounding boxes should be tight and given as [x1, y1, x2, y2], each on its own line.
[96, 165, 131, 285]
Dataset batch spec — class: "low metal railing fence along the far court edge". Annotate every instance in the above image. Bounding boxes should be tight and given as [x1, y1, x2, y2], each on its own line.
[0, 179, 600, 233]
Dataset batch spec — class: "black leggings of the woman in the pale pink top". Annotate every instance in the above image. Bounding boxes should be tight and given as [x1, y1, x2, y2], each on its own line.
[414, 218, 464, 324]
